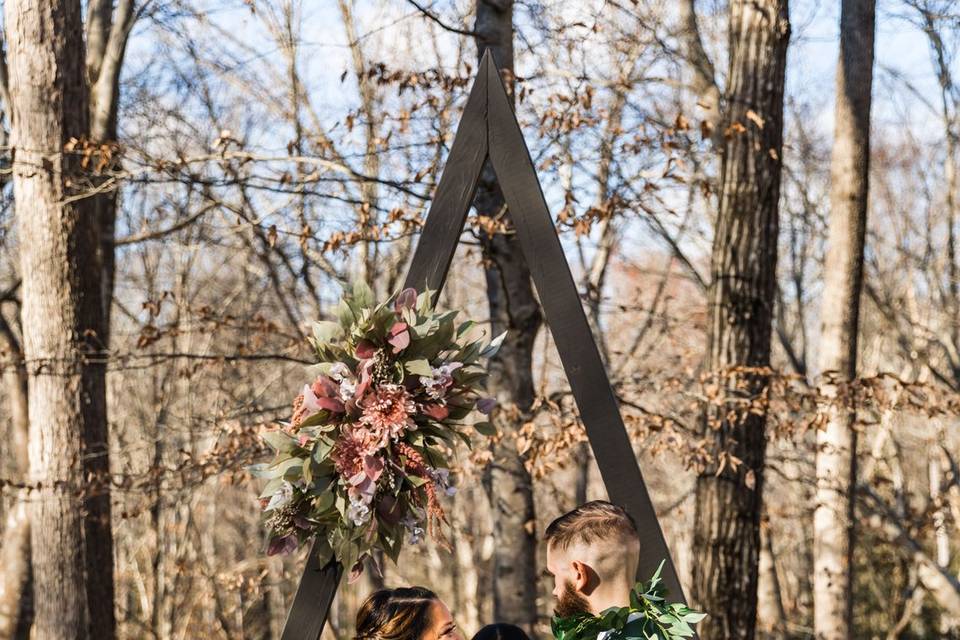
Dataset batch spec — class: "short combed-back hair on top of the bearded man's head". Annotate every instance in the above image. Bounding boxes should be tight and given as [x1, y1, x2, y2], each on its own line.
[544, 500, 640, 550]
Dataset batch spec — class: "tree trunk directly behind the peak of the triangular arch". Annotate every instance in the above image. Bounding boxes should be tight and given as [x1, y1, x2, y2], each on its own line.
[474, 0, 542, 632]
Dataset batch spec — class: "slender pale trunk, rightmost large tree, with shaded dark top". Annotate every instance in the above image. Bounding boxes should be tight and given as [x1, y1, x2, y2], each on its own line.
[813, 0, 875, 640]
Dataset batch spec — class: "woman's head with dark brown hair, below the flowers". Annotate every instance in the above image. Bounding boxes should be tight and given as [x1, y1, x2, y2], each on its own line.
[354, 587, 463, 640]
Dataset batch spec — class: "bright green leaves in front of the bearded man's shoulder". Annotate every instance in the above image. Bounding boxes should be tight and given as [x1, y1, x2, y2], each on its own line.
[550, 562, 707, 640]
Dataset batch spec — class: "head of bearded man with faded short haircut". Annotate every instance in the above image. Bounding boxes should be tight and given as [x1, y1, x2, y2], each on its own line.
[544, 500, 640, 618]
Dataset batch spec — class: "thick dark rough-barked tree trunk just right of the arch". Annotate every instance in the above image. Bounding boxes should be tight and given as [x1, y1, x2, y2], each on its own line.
[693, 0, 790, 639]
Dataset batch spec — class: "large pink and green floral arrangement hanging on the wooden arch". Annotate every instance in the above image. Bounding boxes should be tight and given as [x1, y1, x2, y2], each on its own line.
[251, 283, 503, 579]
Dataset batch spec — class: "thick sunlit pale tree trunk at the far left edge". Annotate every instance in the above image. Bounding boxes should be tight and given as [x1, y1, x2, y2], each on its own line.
[5, 0, 114, 639]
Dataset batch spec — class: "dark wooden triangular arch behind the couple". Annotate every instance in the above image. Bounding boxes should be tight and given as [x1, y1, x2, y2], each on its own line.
[282, 50, 684, 640]
